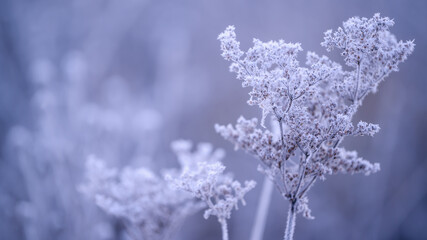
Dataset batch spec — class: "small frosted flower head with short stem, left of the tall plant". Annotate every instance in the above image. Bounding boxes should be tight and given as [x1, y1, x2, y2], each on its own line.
[170, 141, 256, 240]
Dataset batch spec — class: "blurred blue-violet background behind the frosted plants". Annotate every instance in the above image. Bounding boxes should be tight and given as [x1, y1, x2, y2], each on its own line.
[0, 0, 427, 240]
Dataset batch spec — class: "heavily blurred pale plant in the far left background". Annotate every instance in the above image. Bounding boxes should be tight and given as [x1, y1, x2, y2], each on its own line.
[6, 53, 161, 239]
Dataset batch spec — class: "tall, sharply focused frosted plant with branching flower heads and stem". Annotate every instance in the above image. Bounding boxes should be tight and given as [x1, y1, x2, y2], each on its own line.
[219, 14, 414, 239]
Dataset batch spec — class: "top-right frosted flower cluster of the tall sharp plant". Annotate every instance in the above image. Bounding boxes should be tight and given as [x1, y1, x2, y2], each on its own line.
[322, 13, 415, 97]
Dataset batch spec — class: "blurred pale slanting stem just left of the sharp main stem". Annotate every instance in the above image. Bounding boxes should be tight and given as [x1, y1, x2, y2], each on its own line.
[251, 176, 273, 240]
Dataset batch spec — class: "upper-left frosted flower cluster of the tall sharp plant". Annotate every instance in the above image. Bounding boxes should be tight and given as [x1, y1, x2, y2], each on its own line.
[218, 26, 308, 125]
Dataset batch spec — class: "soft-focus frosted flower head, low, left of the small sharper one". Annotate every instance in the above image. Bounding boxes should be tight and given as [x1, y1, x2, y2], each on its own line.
[81, 157, 204, 240]
